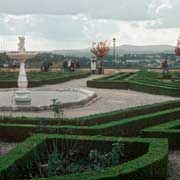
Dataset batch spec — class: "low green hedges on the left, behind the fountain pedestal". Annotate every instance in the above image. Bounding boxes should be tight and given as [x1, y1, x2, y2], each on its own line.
[0, 72, 90, 88]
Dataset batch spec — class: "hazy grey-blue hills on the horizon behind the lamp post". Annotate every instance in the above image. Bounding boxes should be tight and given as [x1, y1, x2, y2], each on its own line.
[53, 45, 175, 57]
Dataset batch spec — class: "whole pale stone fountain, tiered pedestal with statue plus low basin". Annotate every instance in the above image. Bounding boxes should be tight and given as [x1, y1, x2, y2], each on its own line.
[0, 37, 96, 111]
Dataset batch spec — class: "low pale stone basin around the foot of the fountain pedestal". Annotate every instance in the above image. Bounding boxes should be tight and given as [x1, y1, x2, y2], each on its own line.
[0, 88, 97, 111]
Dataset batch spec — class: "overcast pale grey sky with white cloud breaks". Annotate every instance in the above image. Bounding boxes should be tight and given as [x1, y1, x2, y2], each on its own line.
[0, 0, 180, 50]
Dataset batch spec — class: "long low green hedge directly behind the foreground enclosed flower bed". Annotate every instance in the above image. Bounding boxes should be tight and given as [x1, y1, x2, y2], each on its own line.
[0, 100, 180, 141]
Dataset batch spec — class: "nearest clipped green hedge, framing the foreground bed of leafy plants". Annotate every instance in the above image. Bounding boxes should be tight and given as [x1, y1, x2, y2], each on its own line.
[0, 134, 168, 180]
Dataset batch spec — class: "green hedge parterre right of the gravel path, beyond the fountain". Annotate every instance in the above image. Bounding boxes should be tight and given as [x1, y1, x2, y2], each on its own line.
[87, 70, 180, 97]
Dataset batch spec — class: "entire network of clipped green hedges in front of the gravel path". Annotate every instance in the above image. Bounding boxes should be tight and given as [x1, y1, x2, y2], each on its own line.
[0, 100, 180, 180]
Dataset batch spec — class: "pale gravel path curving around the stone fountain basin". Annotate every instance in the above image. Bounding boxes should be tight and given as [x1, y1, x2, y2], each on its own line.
[0, 75, 176, 117]
